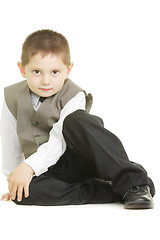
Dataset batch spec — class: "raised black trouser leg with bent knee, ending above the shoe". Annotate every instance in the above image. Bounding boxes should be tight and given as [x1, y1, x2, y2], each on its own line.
[63, 110, 154, 196]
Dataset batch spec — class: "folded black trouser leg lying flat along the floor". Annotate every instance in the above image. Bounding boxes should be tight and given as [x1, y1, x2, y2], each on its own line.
[14, 173, 120, 206]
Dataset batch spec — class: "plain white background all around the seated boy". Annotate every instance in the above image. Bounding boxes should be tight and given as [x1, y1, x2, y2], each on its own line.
[0, 0, 160, 240]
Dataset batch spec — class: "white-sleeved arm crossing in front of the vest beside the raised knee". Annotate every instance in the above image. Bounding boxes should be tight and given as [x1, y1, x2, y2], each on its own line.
[24, 92, 86, 176]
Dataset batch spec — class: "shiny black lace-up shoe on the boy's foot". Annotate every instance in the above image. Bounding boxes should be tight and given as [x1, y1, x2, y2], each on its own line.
[123, 185, 153, 209]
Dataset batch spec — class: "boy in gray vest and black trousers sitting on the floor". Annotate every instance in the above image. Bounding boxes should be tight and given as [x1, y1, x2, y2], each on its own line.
[1, 30, 155, 209]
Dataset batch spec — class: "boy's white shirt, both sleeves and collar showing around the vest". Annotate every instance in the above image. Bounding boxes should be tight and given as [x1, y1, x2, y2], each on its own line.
[0, 92, 86, 176]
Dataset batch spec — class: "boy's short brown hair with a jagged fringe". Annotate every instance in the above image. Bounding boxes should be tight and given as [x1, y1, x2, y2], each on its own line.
[21, 29, 70, 67]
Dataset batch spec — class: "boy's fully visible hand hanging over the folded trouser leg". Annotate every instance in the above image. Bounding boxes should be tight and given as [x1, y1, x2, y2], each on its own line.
[7, 163, 34, 202]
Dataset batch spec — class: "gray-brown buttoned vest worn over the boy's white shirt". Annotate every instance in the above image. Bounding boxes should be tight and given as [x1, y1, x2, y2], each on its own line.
[4, 79, 92, 158]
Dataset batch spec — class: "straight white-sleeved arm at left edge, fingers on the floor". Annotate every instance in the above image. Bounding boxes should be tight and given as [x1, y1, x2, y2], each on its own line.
[0, 101, 33, 200]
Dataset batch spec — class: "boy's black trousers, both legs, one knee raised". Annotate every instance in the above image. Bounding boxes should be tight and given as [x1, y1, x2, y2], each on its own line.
[14, 110, 155, 206]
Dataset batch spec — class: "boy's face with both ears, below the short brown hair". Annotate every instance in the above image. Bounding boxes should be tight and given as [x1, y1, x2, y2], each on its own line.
[18, 53, 73, 97]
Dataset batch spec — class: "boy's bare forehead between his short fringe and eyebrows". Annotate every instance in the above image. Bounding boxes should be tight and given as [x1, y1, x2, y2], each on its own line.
[27, 53, 65, 69]
